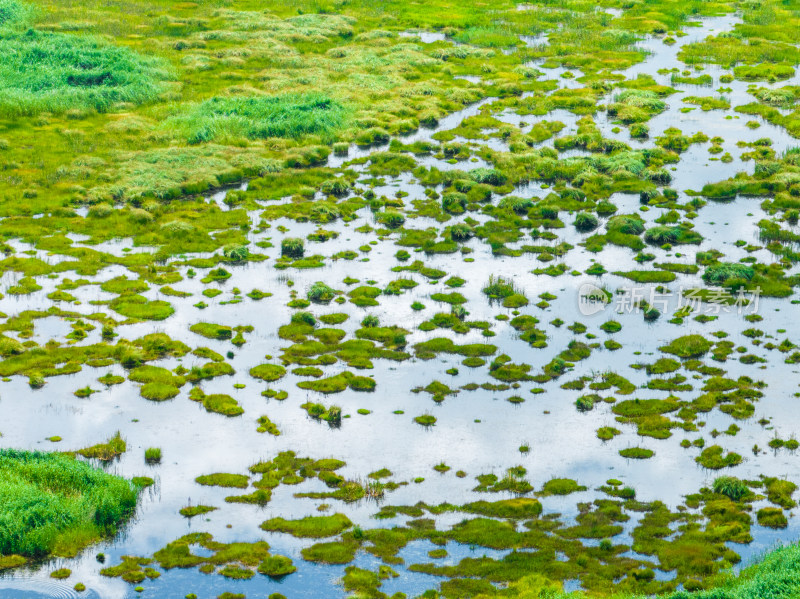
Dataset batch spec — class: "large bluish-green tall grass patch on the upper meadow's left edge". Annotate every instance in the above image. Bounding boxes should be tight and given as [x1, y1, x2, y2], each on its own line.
[0, 28, 168, 117]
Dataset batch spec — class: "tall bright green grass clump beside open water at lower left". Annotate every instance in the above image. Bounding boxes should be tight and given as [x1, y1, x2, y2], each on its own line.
[0, 449, 138, 557]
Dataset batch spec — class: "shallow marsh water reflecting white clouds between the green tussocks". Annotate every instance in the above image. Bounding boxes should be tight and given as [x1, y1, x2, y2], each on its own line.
[0, 8, 800, 599]
